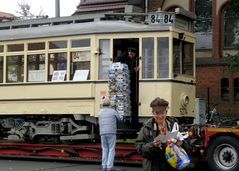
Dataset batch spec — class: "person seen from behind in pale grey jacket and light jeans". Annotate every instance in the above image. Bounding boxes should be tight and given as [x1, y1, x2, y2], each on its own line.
[98, 97, 122, 171]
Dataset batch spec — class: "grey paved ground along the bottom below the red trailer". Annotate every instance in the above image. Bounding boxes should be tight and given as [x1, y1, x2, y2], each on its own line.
[0, 157, 207, 171]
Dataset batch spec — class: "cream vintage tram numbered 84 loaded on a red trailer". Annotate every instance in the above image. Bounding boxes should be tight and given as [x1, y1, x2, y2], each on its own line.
[0, 12, 195, 142]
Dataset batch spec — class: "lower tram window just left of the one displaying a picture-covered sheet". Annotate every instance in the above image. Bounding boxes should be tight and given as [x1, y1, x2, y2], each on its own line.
[27, 54, 45, 82]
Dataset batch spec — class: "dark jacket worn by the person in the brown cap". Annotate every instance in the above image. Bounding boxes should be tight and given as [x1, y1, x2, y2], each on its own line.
[136, 116, 185, 171]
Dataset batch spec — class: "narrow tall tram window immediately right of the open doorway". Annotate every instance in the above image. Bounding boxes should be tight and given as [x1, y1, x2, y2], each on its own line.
[142, 38, 154, 78]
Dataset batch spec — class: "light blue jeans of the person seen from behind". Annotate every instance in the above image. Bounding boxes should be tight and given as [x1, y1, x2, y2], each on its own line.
[101, 134, 116, 170]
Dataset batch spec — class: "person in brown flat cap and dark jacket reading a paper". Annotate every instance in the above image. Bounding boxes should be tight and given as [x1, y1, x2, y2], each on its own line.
[136, 98, 188, 171]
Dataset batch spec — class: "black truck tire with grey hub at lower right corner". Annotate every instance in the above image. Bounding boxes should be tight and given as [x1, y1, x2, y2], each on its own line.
[207, 136, 239, 171]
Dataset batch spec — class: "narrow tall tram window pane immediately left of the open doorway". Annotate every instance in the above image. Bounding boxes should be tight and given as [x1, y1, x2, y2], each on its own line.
[98, 39, 110, 80]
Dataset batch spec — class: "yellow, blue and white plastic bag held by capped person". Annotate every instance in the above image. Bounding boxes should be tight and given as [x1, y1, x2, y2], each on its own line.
[165, 143, 190, 170]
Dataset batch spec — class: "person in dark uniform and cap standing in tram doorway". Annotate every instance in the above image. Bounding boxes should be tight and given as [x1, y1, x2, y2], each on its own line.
[114, 47, 139, 128]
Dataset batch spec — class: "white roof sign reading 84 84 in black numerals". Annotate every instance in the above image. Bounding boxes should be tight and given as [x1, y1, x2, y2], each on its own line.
[148, 12, 175, 26]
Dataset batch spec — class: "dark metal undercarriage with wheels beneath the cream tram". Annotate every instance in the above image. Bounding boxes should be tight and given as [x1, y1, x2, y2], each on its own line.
[0, 115, 98, 143]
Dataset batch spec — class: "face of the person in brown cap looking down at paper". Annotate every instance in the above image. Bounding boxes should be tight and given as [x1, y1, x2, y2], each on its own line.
[152, 106, 168, 123]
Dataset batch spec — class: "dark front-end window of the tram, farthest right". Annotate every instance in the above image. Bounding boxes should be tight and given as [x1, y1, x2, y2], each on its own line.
[173, 39, 194, 75]
